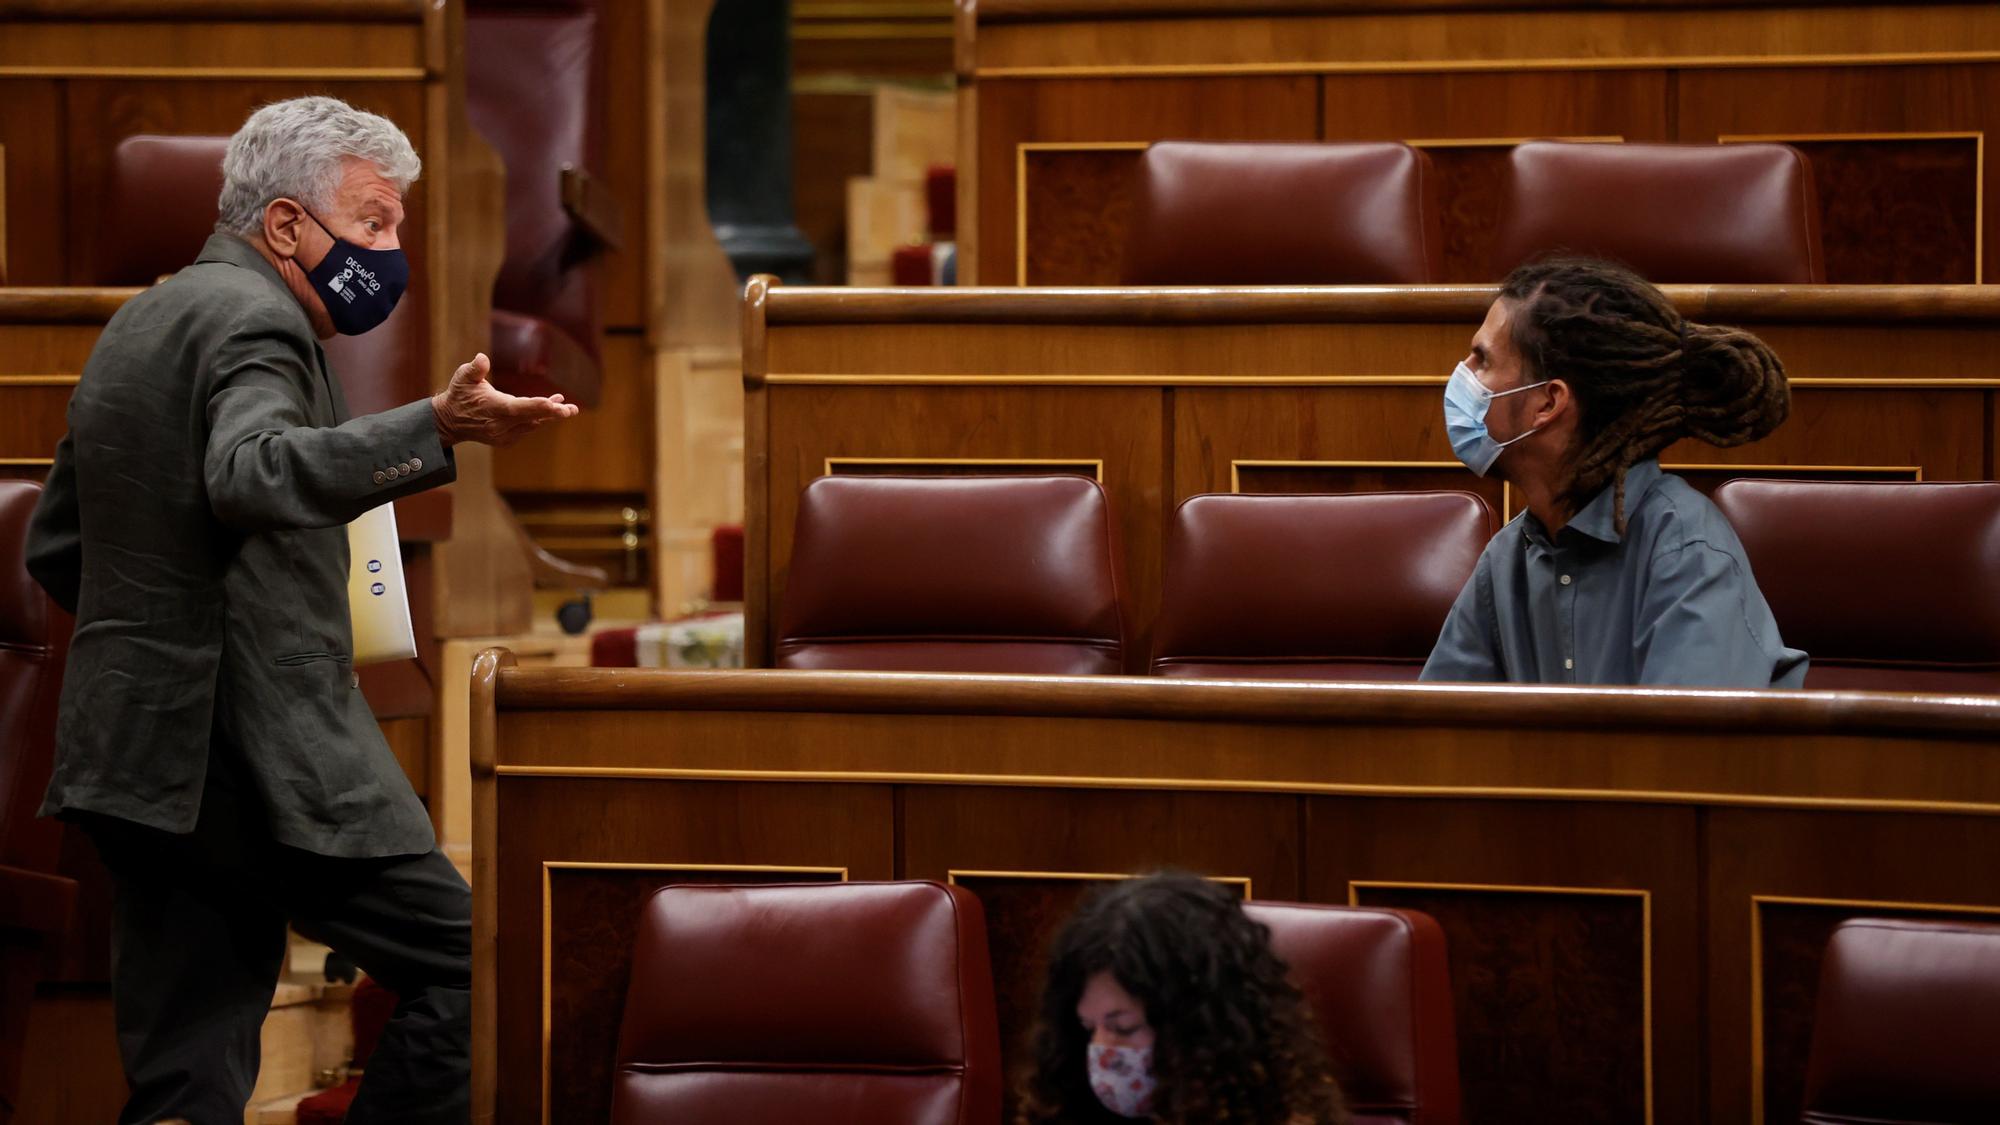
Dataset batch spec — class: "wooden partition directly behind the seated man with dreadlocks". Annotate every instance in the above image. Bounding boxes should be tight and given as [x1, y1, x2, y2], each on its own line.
[744, 282, 2000, 671]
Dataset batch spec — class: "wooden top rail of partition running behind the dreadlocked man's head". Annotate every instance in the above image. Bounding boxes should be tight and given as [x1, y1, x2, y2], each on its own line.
[744, 276, 2000, 328]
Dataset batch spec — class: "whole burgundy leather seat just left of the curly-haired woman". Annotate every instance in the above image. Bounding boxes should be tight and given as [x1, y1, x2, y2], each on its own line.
[612, 883, 1002, 1125]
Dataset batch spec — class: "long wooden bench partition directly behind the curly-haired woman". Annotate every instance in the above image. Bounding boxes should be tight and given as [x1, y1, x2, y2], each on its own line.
[474, 655, 2000, 1123]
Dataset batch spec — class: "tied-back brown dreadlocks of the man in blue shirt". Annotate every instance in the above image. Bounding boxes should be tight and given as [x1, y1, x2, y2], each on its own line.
[1500, 258, 1792, 532]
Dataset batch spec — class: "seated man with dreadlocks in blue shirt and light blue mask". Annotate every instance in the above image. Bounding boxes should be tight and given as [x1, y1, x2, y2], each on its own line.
[1422, 260, 1806, 687]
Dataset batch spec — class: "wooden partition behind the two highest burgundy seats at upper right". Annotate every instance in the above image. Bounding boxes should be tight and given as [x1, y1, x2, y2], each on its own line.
[958, 0, 2000, 284]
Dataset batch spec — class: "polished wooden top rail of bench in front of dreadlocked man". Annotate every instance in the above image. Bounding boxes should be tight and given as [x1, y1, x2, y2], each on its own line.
[494, 667, 2000, 736]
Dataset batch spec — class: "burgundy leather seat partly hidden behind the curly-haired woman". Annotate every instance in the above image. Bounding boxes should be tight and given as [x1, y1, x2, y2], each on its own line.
[1244, 903, 1460, 1125]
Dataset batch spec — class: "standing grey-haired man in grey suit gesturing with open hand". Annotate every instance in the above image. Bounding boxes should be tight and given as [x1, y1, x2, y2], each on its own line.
[28, 98, 576, 1125]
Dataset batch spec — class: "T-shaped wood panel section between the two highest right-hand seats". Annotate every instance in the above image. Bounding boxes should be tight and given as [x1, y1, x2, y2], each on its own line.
[1322, 70, 1670, 282]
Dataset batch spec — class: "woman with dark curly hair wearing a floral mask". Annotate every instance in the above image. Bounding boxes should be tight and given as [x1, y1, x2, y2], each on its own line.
[1018, 875, 1346, 1125]
